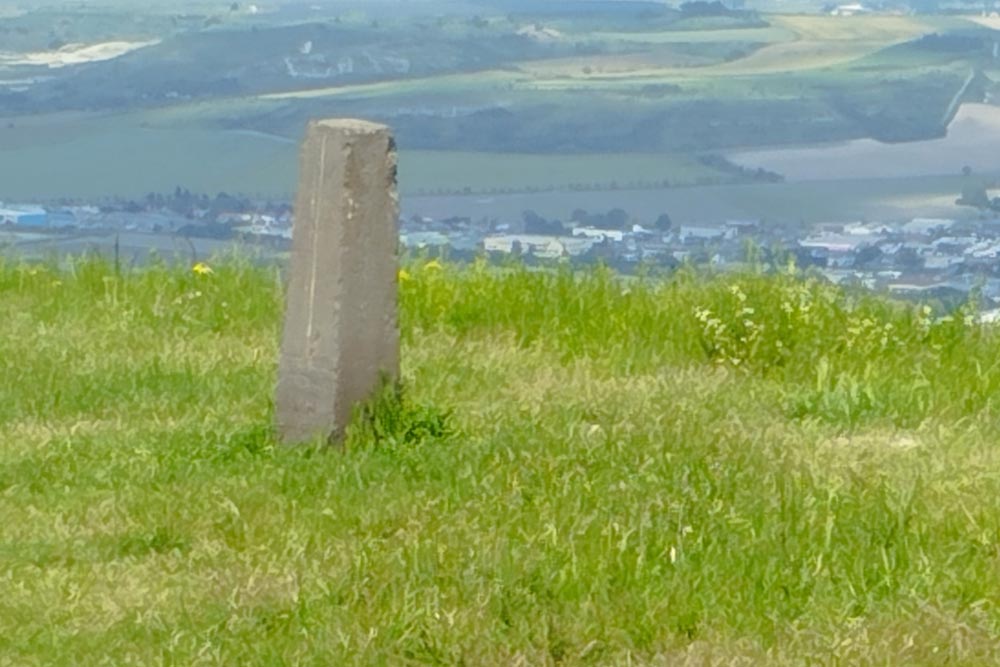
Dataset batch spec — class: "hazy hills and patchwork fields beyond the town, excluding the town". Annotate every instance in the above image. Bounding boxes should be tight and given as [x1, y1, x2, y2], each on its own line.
[0, 0, 1000, 206]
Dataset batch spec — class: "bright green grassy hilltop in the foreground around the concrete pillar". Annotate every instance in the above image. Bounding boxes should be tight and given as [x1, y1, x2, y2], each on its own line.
[0, 259, 1000, 665]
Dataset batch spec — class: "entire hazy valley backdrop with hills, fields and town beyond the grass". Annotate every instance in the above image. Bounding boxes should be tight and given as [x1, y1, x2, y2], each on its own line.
[0, 0, 1000, 296]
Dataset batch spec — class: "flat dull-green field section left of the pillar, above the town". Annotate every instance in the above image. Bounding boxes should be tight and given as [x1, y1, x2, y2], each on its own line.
[0, 114, 296, 201]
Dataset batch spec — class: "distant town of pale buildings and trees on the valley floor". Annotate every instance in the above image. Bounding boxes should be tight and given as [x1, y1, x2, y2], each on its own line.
[0, 188, 1000, 307]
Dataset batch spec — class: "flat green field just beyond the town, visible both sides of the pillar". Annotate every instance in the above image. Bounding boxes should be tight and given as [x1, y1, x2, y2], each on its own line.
[0, 110, 732, 200]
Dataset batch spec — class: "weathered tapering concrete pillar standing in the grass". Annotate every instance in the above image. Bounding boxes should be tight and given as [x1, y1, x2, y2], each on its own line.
[275, 120, 399, 444]
